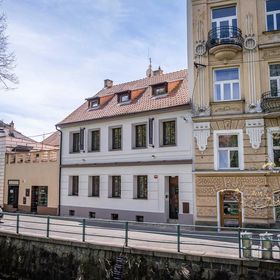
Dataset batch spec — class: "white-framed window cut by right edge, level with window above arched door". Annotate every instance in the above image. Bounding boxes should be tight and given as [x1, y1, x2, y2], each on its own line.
[267, 127, 280, 168]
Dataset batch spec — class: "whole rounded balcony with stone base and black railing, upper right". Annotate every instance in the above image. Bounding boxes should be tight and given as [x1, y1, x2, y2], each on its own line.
[207, 26, 244, 61]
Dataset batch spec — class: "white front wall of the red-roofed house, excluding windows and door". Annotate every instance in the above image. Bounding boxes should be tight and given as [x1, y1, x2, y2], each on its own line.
[61, 109, 194, 223]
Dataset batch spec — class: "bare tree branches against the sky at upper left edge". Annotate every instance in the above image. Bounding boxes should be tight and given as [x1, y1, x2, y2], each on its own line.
[0, 11, 18, 89]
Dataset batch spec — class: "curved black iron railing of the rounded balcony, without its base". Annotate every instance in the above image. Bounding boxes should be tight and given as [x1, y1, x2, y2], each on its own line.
[207, 26, 244, 49]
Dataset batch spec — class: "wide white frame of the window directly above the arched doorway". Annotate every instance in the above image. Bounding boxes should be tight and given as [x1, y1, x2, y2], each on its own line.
[213, 129, 244, 171]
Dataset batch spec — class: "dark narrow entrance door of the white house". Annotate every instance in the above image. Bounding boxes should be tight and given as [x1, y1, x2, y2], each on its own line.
[169, 176, 179, 220]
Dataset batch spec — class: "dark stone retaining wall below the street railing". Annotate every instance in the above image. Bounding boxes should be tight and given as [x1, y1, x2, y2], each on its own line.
[0, 233, 280, 280]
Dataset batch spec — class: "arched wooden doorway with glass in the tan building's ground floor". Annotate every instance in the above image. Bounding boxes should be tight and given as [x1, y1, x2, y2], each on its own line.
[219, 190, 242, 227]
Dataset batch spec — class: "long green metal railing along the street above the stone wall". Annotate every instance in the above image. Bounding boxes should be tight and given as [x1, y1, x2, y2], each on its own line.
[0, 213, 280, 261]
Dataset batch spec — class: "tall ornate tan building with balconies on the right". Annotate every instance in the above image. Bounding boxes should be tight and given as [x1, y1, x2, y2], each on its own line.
[188, 0, 280, 226]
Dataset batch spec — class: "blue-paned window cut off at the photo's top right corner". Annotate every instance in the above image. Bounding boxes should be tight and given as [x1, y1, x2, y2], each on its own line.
[266, 0, 280, 31]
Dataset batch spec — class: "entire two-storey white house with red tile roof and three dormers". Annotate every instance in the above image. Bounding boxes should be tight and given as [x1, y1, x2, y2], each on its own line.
[58, 69, 194, 224]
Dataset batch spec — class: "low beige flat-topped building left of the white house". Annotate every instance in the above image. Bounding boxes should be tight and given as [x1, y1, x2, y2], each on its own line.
[4, 137, 59, 215]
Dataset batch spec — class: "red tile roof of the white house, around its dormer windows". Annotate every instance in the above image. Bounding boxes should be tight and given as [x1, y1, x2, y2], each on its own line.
[58, 70, 190, 125]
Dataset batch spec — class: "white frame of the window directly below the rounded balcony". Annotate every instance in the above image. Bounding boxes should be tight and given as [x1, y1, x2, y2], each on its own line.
[213, 67, 241, 102]
